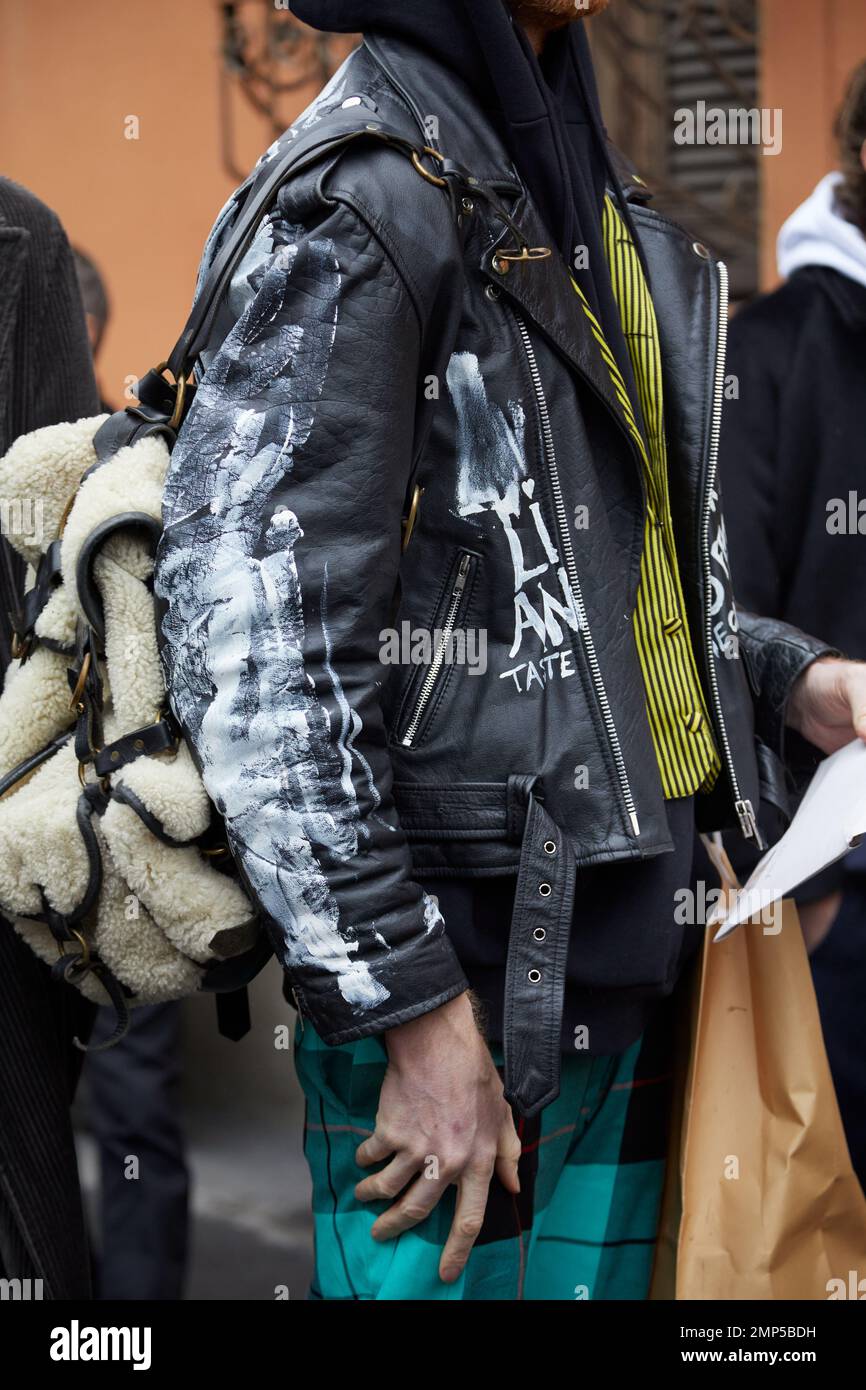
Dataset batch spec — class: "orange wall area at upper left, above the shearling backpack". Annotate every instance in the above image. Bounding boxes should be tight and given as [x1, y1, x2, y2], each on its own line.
[0, 0, 326, 404]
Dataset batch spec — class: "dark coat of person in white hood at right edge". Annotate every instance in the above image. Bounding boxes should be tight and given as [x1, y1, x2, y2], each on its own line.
[720, 265, 866, 659]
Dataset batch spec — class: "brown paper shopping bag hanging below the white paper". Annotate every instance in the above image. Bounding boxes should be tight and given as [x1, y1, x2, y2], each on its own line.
[651, 845, 866, 1300]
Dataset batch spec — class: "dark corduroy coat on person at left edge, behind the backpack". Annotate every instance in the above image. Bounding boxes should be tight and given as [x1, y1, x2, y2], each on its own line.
[0, 179, 99, 1298]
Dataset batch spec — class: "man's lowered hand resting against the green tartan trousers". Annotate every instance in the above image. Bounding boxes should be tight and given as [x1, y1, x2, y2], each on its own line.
[354, 994, 520, 1283]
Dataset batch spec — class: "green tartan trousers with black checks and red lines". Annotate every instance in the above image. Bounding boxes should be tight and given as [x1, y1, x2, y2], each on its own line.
[295, 1005, 673, 1301]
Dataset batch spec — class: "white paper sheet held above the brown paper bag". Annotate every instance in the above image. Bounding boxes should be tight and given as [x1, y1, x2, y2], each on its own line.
[708, 738, 866, 941]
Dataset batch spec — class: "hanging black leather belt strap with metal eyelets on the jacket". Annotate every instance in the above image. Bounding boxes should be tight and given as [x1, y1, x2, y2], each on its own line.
[503, 778, 577, 1119]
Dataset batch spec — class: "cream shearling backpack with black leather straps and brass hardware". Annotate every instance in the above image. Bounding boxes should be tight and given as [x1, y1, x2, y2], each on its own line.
[0, 119, 480, 1047]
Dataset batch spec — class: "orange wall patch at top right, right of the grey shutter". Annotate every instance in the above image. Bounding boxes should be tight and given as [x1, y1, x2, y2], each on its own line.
[760, 0, 866, 286]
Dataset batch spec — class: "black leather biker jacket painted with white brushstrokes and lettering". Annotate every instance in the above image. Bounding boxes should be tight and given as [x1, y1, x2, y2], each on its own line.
[157, 39, 827, 1109]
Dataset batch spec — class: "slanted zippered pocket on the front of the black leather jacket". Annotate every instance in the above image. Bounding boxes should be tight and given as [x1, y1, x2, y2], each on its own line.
[393, 550, 478, 748]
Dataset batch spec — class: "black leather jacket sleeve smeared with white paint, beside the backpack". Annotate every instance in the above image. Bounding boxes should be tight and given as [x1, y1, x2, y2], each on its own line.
[157, 190, 467, 1044]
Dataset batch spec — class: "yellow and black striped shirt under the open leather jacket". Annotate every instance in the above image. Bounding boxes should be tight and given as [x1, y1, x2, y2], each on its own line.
[573, 197, 720, 798]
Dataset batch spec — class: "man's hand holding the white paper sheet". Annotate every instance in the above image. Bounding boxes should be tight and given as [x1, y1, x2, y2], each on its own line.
[785, 656, 866, 753]
